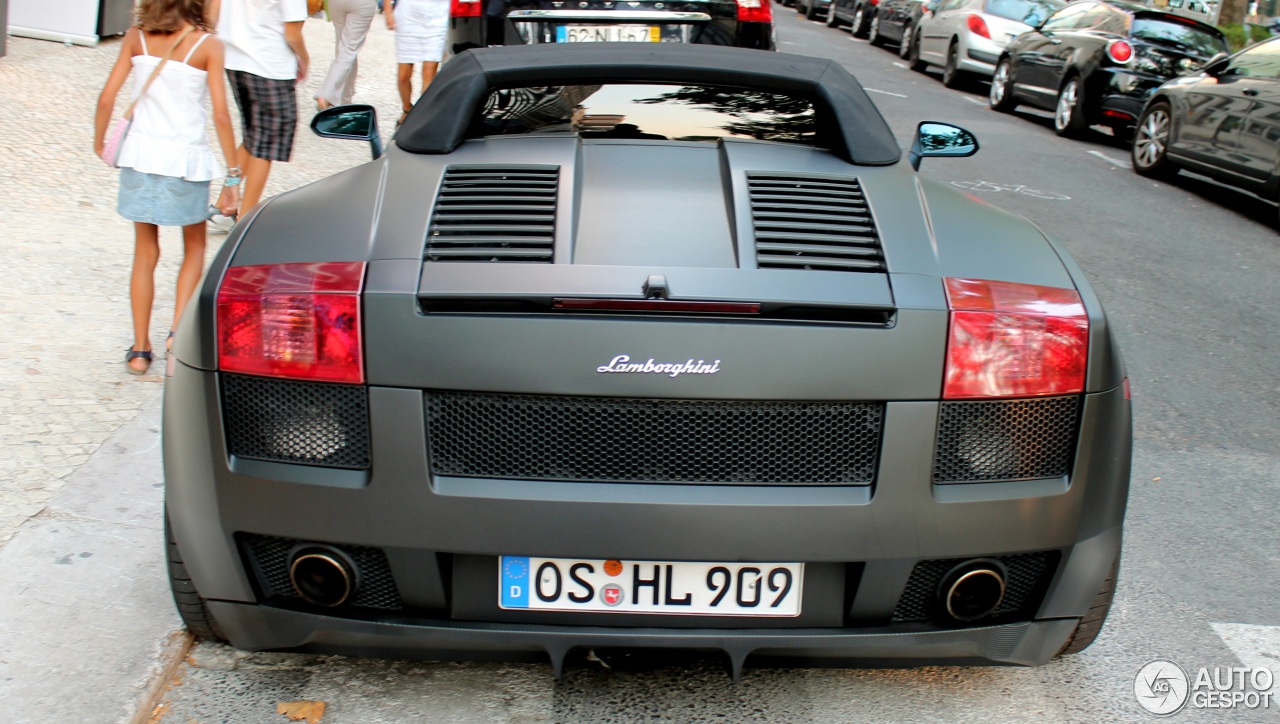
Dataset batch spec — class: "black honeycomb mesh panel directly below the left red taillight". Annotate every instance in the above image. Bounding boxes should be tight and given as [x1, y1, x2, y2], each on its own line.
[221, 375, 370, 469]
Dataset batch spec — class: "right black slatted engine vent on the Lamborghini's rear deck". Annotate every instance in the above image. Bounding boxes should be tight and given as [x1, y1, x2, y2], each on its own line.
[746, 173, 884, 272]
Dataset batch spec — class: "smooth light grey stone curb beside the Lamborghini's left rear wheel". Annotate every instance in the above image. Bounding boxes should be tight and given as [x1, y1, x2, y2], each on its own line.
[0, 391, 183, 724]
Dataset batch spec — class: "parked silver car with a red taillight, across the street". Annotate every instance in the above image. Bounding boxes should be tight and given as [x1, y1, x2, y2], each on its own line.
[908, 0, 1065, 88]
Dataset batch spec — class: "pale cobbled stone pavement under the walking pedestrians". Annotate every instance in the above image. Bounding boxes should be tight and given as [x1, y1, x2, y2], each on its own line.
[0, 18, 399, 547]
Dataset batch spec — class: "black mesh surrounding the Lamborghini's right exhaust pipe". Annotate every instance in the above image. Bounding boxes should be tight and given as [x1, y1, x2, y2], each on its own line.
[892, 551, 1059, 623]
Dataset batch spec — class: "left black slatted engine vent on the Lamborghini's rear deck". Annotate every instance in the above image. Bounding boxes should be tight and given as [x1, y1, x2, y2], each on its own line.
[426, 166, 559, 264]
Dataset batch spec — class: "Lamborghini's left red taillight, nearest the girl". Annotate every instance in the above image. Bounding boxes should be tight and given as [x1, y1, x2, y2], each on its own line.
[218, 261, 365, 384]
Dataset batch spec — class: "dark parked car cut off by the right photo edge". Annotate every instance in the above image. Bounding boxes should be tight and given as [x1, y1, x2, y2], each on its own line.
[1133, 38, 1280, 218]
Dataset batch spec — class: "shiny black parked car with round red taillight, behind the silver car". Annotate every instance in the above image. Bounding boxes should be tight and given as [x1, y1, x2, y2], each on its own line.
[991, 0, 1226, 136]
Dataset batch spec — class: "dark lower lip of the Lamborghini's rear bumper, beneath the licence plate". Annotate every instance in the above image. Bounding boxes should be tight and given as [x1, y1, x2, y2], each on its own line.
[210, 601, 1076, 674]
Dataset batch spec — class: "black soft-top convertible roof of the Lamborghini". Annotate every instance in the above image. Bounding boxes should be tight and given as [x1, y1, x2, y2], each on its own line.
[396, 42, 901, 166]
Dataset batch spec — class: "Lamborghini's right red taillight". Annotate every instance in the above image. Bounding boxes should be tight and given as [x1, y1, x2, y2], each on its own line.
[942, 279, 1089, 399]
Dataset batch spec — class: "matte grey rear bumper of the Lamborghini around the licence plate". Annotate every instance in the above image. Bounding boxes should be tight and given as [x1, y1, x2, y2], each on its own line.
[164, 363, 1130, 665]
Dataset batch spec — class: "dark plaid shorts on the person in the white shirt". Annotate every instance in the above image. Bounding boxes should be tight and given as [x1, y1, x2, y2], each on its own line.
[227, 70, 298, 161]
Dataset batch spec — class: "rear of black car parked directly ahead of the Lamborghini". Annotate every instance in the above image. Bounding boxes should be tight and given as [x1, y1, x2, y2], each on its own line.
[447, 0, 776, 55]
